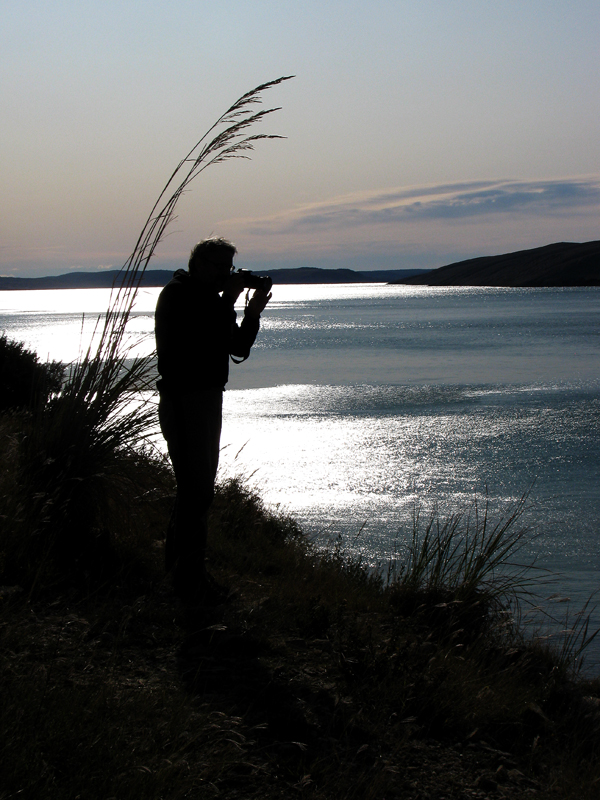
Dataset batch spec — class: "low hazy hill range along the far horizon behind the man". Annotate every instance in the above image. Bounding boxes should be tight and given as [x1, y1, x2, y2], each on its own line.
[0, 267, 429, 291]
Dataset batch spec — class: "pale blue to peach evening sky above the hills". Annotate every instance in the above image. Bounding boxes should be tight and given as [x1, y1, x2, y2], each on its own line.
[0, 0, 600, 277]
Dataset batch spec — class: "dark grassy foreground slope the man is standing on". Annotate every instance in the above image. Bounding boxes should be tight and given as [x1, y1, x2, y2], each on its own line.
[0, 456, 600, 800]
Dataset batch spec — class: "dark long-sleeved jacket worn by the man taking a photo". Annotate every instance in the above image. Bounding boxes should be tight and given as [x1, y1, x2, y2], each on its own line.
[154, 269, 260, 394]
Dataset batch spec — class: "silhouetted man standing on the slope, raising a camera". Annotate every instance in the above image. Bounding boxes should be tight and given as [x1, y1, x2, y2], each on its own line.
[155, 239, 271, 602]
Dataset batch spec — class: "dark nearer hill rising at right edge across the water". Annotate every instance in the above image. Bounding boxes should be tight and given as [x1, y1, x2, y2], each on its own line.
[393, 241, 600, 286]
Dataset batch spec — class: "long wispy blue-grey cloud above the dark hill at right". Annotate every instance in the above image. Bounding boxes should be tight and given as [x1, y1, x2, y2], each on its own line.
[233, 176, 600, 233]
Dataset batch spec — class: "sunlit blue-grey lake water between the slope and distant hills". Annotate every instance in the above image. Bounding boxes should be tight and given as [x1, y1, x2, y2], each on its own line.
[0, 284, 600, 665]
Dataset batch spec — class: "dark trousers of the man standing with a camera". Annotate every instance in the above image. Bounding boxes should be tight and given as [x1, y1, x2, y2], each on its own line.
[158, 389, 223, 591]
